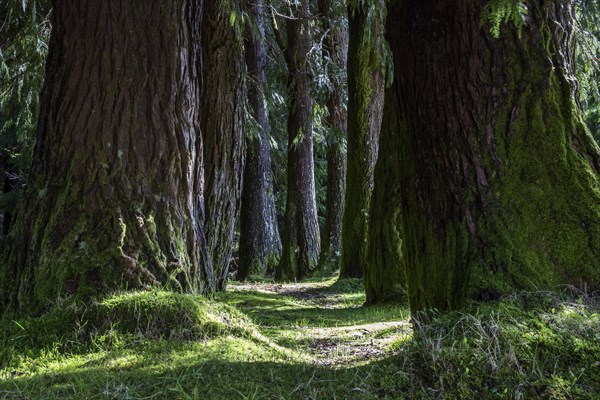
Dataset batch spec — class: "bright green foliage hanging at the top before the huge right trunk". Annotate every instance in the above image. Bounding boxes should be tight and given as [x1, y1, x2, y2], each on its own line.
[479, 0, 527, 38]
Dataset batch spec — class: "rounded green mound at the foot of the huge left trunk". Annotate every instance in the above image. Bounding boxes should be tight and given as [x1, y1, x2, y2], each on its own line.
[0, 290, 256, 350]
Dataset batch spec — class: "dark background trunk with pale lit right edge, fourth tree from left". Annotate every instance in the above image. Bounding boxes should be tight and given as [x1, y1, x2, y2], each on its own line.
[275, 0, 321, 280]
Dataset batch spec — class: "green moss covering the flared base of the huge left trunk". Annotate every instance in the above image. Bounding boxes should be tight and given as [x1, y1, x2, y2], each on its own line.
[3, 195, 211, 314]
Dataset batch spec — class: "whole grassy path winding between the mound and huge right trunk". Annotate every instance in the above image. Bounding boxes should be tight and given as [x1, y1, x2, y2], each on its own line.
[219, 281, 412, 366]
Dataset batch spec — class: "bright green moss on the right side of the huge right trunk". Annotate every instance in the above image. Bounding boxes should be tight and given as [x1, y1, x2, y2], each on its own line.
[471, 59, 600, 293]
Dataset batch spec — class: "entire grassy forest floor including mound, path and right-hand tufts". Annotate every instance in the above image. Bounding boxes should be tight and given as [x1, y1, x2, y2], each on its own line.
[0, 280, 600, 399]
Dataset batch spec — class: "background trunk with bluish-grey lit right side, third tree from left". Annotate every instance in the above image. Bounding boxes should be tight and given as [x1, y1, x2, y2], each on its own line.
[237, 0, 281, 279]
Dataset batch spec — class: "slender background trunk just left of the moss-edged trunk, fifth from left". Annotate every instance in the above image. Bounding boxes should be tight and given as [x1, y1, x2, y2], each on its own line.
[319, 0, 348, 271]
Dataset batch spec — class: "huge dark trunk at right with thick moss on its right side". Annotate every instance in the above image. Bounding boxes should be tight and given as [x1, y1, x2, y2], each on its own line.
[382, 0, 600, 310]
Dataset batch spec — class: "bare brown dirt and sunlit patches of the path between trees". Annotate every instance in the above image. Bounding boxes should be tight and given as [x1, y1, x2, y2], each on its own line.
[227, 282, 412, 366]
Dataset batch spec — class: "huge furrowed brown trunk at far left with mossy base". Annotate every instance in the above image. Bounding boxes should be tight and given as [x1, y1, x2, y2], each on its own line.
[0, 0, 214, 311]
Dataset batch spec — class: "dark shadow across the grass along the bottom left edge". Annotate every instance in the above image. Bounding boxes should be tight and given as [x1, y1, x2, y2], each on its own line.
[0, 346, 408, 399]
